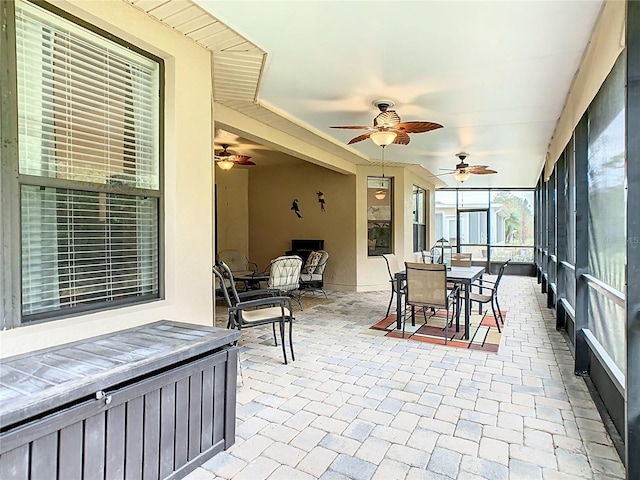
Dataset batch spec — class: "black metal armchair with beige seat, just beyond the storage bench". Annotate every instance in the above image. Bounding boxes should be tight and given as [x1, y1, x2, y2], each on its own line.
[213, 262, 296, 365]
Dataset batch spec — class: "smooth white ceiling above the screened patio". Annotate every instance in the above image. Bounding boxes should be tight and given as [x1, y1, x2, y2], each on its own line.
[197, 0, 602, 187]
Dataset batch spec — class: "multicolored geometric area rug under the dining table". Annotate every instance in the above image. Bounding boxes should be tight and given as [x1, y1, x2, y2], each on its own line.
[369, 309, 507, 353]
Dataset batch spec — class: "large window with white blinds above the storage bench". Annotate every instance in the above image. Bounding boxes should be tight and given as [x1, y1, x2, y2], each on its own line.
[15, 1, 162, 322]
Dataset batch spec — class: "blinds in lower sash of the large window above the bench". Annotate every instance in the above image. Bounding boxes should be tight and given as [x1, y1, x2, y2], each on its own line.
[21, 185, 158, 315]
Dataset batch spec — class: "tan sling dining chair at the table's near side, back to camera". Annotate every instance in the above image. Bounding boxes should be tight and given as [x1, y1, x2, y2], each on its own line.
[402, 262, 460, 344]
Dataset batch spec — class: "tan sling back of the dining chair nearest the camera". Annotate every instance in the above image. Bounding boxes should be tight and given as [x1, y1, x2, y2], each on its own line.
[405, 262, 447, 308]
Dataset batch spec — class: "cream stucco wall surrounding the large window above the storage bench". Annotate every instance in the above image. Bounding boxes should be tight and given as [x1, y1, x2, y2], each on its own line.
[0, 0, 213, 357]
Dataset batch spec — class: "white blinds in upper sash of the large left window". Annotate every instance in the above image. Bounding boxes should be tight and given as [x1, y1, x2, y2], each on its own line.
[16, 3, 159, 189]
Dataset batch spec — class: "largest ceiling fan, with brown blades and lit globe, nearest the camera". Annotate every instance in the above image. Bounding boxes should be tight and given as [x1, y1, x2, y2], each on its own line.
[330, 99, 442, 147]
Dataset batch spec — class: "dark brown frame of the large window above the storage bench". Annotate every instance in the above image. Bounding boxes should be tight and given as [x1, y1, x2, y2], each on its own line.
[0, 0, 165, 328]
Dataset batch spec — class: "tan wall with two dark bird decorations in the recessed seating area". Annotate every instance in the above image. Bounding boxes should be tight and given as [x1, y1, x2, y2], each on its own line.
[249, 163, 356, 290]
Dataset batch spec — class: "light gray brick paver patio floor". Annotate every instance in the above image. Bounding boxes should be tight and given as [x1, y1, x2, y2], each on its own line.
[187, 276, 625, 480]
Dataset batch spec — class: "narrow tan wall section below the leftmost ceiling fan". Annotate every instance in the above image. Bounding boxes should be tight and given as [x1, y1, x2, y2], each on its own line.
[215, 167, 249, 255]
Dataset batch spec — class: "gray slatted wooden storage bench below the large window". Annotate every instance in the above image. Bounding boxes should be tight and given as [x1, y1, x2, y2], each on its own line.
[0, 321, 240, 480]
